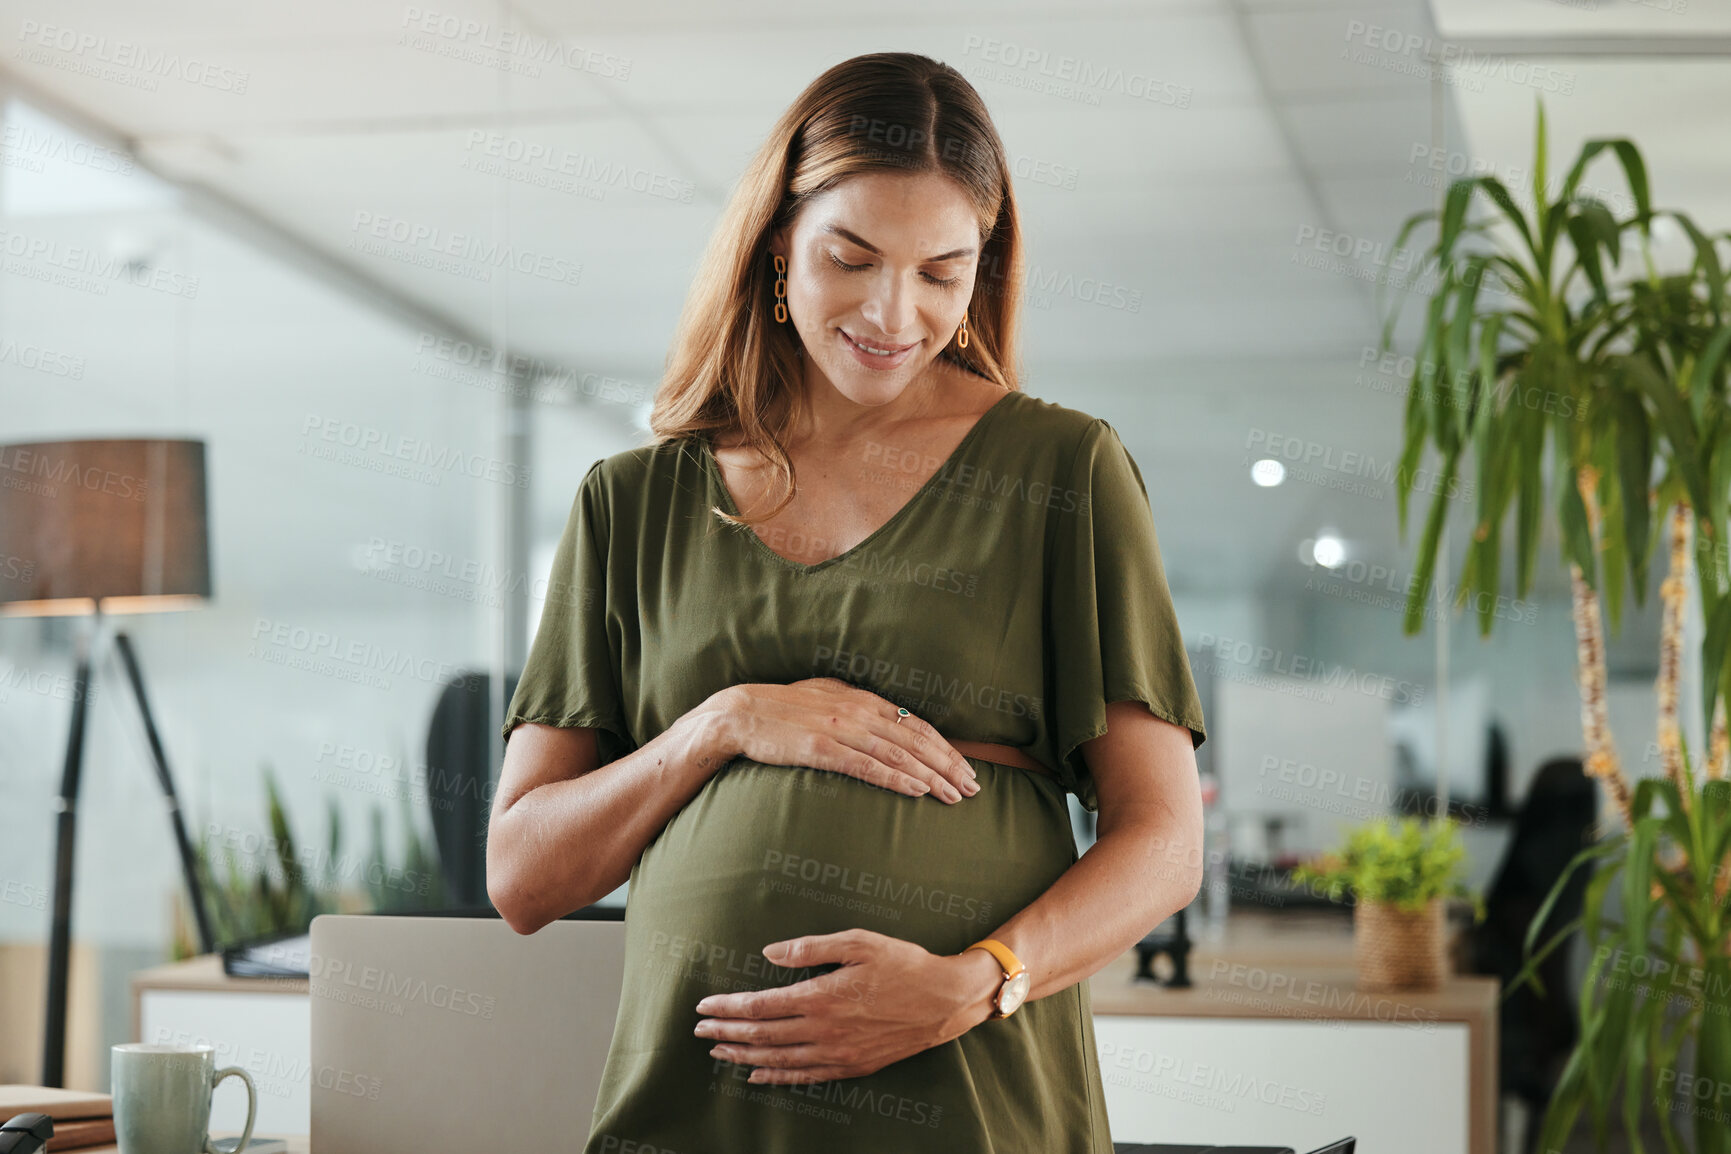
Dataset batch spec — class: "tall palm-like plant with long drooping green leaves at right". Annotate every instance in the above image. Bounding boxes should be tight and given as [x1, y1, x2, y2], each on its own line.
[1383, 102, 1731, 1154]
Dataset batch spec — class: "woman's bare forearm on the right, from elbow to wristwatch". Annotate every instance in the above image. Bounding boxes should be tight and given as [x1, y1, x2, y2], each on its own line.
[988, 808, 1201, 1002]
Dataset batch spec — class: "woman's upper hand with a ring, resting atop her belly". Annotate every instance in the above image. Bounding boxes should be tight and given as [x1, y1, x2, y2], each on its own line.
[711, 676, 980, 803]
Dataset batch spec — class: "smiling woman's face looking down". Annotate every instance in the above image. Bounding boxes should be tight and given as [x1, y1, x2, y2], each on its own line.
[770, 173, 980, 405]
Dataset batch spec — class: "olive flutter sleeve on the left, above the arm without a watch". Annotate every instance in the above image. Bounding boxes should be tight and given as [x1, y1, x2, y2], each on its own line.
[502, 460, 635, 765]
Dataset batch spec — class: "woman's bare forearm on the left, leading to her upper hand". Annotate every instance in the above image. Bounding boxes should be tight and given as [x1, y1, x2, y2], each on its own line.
[486, 704, 734, 933]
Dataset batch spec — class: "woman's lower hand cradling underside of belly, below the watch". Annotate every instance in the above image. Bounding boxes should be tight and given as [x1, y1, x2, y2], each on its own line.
[694, 929, 1004, 1083]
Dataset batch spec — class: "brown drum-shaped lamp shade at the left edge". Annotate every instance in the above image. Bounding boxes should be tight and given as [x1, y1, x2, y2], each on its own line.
[0, 438, 211, 616]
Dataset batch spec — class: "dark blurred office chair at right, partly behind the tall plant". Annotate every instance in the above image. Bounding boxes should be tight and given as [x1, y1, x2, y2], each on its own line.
[1468, 758, 1598, 1154]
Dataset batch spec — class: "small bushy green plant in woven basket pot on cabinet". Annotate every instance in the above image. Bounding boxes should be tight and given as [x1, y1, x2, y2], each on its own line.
[1293, 817, 1485, 990]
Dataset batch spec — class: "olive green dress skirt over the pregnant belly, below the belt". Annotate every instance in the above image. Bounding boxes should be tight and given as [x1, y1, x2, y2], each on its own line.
[583, 756, 1111, 1154]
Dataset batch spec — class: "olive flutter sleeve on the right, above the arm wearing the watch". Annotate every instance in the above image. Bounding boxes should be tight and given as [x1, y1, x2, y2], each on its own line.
[1047, 419, 1207, 810]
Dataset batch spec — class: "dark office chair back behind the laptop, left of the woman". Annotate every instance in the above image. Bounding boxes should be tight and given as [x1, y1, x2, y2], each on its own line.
[428, 670, 518, 908]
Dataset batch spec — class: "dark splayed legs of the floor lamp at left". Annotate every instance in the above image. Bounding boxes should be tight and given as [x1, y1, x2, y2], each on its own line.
[42, 602, 216, 1087]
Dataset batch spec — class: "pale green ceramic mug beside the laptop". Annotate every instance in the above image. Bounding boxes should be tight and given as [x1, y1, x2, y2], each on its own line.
[111, 1042, 258, 1154]
